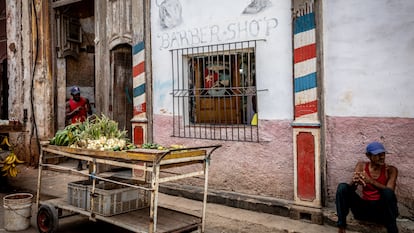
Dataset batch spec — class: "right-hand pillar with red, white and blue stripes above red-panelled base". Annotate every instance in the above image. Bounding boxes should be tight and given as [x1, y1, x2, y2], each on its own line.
[292, 0, 321, 213]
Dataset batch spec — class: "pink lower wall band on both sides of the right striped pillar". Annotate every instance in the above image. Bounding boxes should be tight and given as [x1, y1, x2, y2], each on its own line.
[154, 115, 414, 215]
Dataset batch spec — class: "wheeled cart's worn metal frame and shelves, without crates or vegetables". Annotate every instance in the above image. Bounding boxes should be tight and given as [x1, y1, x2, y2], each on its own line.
[36, 144, 221, 233]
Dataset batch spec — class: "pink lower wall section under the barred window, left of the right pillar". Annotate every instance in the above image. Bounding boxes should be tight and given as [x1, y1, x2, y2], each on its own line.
[154, 115, 294, 200]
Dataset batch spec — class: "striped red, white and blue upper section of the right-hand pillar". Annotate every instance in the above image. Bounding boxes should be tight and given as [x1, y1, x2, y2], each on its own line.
[293, 1, 318, 121]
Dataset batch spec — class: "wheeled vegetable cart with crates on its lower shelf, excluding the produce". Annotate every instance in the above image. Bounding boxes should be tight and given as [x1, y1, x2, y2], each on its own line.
[36, 144, 220, 233]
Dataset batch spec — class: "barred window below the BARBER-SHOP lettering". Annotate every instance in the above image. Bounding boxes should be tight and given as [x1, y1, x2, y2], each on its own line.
[171, 41, 259, 142]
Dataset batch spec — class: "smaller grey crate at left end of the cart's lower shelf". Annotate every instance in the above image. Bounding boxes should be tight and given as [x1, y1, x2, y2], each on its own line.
[67, 180, 92, 209]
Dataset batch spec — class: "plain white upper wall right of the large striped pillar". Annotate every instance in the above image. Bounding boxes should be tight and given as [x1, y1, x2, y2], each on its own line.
[323, 0, 414, 118]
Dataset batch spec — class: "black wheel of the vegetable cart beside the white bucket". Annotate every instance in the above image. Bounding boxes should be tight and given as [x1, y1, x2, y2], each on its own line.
[37, 204, 59, 233]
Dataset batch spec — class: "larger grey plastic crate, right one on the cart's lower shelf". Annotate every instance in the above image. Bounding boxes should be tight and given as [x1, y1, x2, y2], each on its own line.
[87, 180, 151, 216]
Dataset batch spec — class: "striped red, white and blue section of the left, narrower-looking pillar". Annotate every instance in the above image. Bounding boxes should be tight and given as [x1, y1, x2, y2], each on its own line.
[132, 41, 147, 117]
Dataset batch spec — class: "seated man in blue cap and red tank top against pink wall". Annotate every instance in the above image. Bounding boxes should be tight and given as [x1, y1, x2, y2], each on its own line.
[336, 142, 398, 233]
